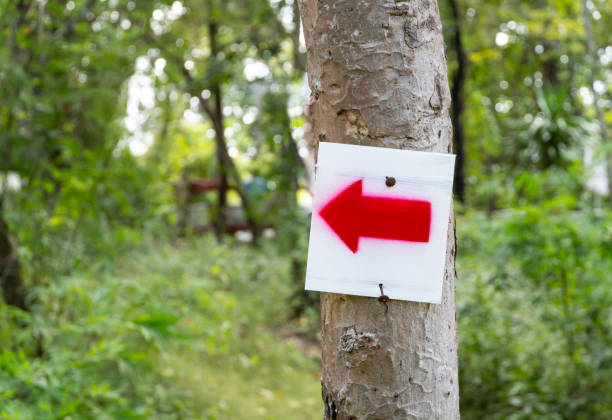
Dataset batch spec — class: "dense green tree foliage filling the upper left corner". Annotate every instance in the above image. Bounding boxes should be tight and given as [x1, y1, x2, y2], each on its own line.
[0, 1, 168, 284]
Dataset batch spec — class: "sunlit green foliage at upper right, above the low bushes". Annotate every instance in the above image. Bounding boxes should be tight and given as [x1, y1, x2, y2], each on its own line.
[439, 0, 612, 208]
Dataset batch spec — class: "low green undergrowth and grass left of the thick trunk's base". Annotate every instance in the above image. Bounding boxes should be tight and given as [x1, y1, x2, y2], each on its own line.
[0, 238, 321, 419]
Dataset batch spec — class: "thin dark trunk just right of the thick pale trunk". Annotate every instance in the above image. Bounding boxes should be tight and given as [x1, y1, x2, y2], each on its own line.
[449, 0, 467, 202]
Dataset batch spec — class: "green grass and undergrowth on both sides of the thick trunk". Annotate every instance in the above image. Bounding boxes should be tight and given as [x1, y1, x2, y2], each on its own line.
[5, 207, 612, 420]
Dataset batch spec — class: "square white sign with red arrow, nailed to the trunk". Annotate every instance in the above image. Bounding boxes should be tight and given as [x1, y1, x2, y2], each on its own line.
[306, 142, 455, 303]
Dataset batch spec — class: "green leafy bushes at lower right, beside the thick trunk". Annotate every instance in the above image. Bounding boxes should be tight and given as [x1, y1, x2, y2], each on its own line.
[457, 202, 612, 419]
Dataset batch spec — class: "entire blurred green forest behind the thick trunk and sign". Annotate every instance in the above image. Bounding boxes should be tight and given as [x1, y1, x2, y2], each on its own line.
[0, 0, 612, 419]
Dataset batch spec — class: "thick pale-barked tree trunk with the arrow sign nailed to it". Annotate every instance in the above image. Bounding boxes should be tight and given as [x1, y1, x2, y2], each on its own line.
[300, 0, 459, 420]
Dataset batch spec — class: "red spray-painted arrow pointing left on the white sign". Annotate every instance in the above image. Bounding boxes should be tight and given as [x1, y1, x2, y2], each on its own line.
[319, 179, 431, 253]
